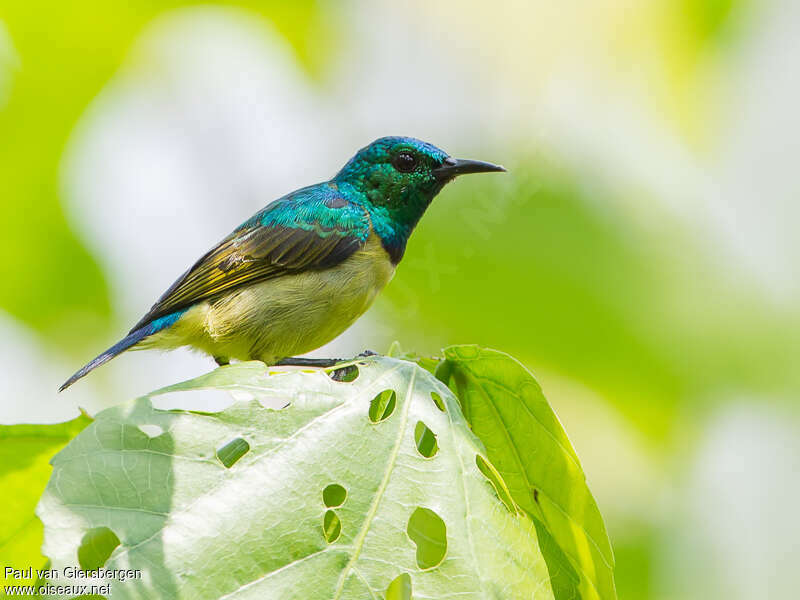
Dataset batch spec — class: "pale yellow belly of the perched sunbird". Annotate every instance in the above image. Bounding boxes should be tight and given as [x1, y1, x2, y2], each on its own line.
[146, 235, 394, 364]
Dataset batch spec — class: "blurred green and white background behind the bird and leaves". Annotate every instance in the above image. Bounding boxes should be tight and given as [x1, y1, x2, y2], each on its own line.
[0, 0, 800, 599]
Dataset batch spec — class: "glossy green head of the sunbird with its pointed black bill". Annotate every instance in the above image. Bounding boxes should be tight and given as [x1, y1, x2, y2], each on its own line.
[334, 137, 505, 218]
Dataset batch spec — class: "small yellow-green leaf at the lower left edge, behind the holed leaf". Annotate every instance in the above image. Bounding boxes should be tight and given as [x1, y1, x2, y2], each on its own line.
[0, 415, 91, 586]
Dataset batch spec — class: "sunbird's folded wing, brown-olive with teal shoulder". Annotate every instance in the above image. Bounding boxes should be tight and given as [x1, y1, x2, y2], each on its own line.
[131, 188, 370, 331]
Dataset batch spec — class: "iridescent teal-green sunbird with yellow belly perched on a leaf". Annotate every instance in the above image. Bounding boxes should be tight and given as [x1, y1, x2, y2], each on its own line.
[59, 137, 505, 391]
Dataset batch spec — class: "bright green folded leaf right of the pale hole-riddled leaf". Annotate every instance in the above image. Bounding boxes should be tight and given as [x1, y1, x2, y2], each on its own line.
[437, 346, 616, 600]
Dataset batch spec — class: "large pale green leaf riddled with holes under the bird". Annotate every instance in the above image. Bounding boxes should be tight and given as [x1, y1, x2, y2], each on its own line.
[37, 358, 553, 600]
